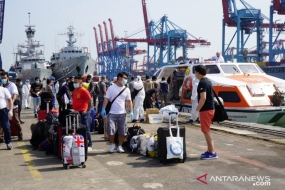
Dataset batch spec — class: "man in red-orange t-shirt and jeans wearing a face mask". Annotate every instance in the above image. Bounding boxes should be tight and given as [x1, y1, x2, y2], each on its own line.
[72, 76, 92, 151]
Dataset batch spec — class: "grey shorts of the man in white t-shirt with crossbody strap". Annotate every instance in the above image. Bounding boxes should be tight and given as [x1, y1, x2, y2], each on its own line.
[107, 113, 127, 136]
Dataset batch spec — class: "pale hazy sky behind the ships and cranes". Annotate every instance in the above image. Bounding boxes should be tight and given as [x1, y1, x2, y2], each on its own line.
[0, 0, 285, 69]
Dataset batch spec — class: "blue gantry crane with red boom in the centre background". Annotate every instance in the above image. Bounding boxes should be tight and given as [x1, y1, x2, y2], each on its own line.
[115, 0, 211, 75]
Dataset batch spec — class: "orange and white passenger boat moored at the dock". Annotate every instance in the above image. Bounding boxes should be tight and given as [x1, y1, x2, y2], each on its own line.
[155, 63, 285, 127]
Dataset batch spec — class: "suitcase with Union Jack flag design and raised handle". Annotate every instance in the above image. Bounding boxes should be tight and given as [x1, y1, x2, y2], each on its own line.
[61, 114, 86, 169]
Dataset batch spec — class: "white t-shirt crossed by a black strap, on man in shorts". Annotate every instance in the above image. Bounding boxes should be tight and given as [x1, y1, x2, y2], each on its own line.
[105, 84, 131, 114]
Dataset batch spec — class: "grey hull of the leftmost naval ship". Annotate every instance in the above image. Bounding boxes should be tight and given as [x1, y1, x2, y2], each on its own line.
[17, 68, 52, 83]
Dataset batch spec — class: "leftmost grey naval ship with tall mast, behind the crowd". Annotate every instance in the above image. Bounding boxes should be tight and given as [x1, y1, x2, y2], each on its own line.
[10, 25, 52, 83]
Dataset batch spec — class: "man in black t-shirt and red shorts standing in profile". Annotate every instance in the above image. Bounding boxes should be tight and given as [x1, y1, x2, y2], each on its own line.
[195, 65, 218, 160]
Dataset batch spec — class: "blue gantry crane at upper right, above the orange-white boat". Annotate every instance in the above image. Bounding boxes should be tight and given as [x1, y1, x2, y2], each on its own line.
[222, 0, 282, 62]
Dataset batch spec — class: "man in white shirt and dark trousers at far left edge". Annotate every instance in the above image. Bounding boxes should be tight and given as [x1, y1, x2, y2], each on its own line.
[1, 72, 23, 141]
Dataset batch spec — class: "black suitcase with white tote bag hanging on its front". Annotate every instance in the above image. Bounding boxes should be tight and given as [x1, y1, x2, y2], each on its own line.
[157, 112, 187, 164]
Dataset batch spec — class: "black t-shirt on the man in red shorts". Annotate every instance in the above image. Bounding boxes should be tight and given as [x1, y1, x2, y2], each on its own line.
[197, 78, 215, 111]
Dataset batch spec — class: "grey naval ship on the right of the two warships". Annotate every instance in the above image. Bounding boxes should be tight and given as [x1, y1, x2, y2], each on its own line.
[50, 26, 96, 81]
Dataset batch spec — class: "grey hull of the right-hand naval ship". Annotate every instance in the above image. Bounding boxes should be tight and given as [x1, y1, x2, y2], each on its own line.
[51, 56, 96, 80]
